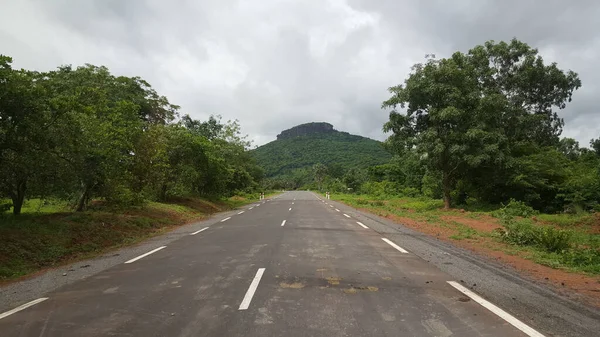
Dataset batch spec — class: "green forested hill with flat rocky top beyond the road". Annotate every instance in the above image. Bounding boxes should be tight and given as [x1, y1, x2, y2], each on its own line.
[252, 123, 391, 177]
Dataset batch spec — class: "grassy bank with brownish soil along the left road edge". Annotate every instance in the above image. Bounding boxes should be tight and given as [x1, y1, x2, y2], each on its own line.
[0, 194, 268, 281]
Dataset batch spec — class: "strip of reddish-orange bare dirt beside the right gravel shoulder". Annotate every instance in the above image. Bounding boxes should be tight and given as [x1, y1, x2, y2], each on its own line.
[365, 210, 600, 307]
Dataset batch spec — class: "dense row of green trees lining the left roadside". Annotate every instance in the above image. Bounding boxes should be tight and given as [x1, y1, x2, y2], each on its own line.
[0, 56, 262, 215]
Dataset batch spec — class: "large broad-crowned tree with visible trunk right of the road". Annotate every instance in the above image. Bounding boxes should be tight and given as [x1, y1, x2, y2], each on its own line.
[382, 39, 581, 208]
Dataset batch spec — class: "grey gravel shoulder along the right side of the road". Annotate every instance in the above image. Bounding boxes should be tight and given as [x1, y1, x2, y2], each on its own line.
[330, 200, 600, 337]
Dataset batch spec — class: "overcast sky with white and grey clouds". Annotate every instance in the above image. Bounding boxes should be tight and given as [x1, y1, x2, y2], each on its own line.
[0, 0, 600, 145]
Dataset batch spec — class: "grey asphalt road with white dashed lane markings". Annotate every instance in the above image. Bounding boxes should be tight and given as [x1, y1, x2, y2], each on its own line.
[0, 192, 598, 337]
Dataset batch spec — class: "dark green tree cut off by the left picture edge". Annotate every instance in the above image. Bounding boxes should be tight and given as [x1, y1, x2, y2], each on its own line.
[0, 55, 60, 215]
